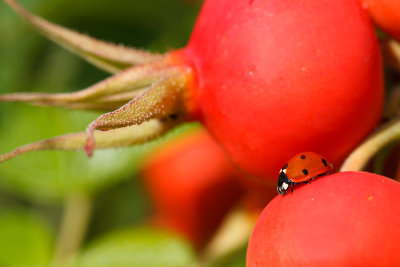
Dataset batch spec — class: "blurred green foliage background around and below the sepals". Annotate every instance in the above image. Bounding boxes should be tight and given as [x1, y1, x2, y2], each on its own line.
[0, 0, 245, 267]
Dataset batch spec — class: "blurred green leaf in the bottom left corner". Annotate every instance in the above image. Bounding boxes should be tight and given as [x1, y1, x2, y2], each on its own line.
[0, 211, 53, 267]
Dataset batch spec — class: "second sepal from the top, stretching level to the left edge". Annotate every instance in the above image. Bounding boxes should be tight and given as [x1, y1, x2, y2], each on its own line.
[0, 60, 175, 111]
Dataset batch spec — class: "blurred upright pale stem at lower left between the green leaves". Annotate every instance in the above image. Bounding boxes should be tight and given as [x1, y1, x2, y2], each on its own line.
[51, 193, 92, 267]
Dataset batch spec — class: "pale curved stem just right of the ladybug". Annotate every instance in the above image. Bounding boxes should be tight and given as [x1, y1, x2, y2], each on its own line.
[340, 118, 400, 171]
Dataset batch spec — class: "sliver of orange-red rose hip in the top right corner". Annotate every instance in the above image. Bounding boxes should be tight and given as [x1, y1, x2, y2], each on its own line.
[359, 0, 400, 40]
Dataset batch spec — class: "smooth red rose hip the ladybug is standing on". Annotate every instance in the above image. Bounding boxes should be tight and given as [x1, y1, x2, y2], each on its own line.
[246, 172, 400, 267]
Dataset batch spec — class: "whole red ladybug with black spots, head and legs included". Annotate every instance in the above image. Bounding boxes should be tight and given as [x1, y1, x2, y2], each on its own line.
[277, 152, 333, 196]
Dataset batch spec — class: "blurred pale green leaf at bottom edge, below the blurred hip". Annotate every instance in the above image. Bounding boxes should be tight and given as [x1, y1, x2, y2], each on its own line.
[77, 228, 194, 267]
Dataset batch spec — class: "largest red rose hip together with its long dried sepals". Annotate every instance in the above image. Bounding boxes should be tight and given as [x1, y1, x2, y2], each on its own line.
[0, 0, 383, 184]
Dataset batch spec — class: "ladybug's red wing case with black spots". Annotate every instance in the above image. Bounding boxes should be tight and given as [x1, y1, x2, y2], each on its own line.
[286, 152, 333, 183]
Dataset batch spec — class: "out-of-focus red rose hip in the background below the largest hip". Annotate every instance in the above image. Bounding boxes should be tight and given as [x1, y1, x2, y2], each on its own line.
[143, 131, 243, 248]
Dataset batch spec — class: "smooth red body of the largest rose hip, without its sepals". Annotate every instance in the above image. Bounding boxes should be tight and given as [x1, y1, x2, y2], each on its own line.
[180, 0, 383, 185]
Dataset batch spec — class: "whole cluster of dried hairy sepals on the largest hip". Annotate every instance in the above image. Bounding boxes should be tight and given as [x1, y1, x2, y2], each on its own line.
[0, 0, 191, 162]
